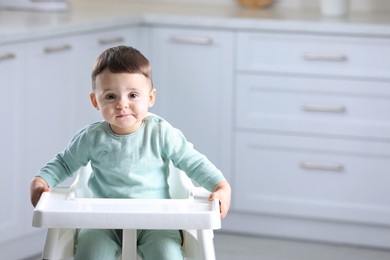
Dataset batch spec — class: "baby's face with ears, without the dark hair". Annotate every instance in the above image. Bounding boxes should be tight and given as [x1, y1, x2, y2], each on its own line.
[91, 70, 156, 135]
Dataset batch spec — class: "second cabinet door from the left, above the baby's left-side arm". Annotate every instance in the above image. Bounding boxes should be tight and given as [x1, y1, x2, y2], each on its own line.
[23, 37, 78, 193]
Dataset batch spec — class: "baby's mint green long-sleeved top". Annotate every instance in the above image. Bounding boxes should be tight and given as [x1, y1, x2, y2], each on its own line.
[37, 114, 225, 199]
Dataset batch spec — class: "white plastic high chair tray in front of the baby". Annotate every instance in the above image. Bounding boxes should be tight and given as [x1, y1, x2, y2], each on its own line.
[33, 188, 221, 229]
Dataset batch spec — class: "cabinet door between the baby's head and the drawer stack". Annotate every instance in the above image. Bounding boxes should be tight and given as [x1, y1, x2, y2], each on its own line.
[151, 28, 233, 180]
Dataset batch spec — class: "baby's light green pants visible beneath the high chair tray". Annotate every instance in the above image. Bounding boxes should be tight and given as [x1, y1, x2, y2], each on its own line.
[75, 229, 183, 260]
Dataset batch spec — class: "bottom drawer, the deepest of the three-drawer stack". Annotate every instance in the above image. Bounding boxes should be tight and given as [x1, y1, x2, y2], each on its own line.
[234, 133, 390, 225]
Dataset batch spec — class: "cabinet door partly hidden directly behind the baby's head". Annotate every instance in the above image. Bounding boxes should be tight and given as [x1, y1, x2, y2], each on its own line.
[71, 27, 146, 132]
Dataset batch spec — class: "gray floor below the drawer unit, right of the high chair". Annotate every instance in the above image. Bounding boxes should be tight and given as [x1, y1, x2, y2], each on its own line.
[214, 233, 390, 260]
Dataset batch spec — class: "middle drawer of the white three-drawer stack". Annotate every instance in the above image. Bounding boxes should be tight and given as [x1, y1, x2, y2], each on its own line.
[236, 75, 390, 138]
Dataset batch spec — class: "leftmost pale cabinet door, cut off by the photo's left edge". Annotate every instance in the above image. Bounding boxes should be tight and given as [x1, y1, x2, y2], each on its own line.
[0, 45, 24, 243]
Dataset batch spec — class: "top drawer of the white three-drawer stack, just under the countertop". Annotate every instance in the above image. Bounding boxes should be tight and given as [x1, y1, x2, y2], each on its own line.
[238, 32, 390, 78]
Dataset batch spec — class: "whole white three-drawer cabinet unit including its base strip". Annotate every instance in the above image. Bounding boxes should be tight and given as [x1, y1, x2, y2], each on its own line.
[227, 32, 390, 247]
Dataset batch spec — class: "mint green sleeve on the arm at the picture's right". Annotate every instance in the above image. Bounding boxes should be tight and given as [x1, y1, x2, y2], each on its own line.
[162, 124, 225, 191]
